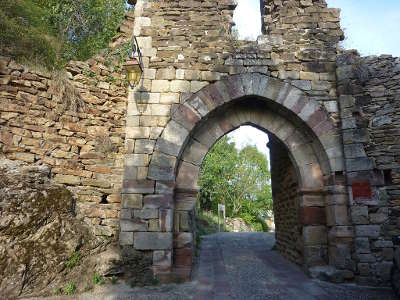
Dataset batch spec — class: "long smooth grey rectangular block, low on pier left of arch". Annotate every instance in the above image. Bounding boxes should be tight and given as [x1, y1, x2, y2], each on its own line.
[133, 232, 172, 250]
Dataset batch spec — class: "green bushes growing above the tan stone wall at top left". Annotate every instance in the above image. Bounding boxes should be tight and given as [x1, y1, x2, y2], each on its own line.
[0, 0, 128, 69]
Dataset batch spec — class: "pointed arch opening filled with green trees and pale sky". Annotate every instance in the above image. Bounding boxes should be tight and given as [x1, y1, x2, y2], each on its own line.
[196, 125, 274, 234]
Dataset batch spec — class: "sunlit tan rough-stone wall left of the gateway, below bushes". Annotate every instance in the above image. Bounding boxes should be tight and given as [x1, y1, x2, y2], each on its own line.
[0, 12, 134, 237]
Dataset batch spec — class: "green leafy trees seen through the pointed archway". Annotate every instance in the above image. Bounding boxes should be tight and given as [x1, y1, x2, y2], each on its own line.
[199, 136, 273, 231]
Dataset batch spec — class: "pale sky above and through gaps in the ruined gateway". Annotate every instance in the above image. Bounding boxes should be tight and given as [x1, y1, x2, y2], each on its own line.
[230, 0, 400, 155]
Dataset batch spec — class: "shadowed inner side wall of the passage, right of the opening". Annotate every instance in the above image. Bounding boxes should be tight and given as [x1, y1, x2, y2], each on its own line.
[268, 135, 303, 265]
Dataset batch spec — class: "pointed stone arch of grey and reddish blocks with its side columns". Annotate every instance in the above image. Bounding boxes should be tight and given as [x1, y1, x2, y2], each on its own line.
[148, 73, 348, 275]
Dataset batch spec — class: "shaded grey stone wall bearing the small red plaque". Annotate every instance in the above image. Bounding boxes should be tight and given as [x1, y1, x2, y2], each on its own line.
[337, 51, 400, 284]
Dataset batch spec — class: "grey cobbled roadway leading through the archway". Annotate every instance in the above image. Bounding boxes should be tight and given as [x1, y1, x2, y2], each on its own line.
[27, 233, 397, 300]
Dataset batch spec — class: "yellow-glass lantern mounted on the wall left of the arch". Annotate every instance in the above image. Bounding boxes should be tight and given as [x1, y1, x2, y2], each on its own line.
[124, 36, 143, 88]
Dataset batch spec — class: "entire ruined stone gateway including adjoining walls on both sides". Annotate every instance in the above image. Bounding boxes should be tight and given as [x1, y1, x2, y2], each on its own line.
[0, 0, 400, 294]
